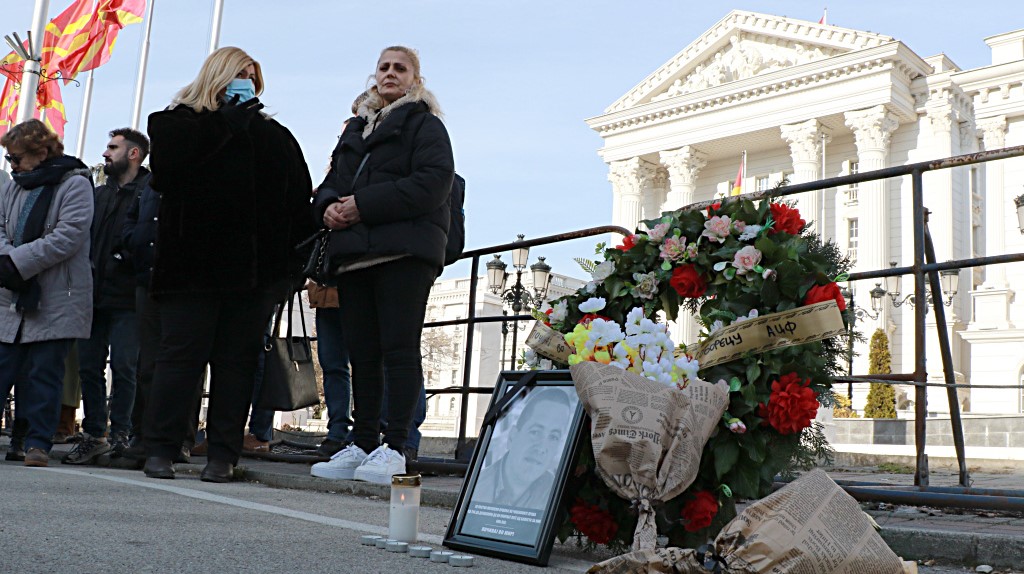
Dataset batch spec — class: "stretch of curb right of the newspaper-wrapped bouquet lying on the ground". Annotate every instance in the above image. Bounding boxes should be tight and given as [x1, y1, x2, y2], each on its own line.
[880, 526, 1024, 568]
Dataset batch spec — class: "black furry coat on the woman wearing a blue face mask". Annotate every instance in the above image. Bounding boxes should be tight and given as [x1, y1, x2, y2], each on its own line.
[148, 105, 315, 298]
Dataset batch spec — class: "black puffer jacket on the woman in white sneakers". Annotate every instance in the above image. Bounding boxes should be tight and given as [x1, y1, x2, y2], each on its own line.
[314, 95, 455, 270]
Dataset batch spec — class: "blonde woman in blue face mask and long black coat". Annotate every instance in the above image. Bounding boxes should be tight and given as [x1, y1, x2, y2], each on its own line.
[143, 47, 315, 482]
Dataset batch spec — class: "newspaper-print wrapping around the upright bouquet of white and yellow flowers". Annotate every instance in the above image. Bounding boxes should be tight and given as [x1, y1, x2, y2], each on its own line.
[569, 361, 729, 550]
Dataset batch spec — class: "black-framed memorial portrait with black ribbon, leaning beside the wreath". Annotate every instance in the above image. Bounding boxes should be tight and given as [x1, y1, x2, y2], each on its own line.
[444, 370, 584, 566]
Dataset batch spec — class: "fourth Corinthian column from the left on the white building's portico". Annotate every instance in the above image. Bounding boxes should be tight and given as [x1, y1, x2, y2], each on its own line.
[845, 105, 899, 317]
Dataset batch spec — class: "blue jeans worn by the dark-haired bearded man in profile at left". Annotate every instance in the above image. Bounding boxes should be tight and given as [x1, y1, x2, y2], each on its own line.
[78, 309, 138, 437]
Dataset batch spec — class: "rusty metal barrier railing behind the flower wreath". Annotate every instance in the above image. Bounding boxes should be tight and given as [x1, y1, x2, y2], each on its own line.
[424, 145, 1024, 511]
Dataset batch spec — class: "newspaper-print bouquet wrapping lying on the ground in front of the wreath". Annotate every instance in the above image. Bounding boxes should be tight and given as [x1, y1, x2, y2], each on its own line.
[589, 470, 918, 574]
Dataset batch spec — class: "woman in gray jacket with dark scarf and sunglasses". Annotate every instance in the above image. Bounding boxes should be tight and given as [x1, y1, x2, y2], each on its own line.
[0, 120, 93, 467]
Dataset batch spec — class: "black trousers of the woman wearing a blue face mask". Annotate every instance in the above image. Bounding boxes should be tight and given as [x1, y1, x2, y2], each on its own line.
[143, 292, 273, 465]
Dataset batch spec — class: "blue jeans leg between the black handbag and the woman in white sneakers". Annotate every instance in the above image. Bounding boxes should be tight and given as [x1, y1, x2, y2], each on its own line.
[316, 308, 352, 442]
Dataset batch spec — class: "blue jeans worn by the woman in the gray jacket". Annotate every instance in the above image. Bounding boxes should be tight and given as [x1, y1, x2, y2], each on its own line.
[0, 339, 71, 452]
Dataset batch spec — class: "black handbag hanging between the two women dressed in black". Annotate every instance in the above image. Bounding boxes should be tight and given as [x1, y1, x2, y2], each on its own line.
[255, 292, 319, 411]
